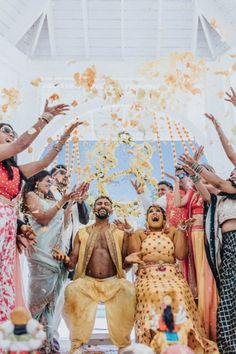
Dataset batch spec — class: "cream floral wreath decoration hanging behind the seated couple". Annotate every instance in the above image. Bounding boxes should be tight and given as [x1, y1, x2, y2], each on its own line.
[77, 131, 156, 217]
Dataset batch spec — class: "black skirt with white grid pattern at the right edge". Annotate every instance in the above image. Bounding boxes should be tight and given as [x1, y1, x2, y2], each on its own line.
[217, 230, 236, 354]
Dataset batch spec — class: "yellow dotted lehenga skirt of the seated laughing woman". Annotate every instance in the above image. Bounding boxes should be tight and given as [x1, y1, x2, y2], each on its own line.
[135, 263, 218, 354]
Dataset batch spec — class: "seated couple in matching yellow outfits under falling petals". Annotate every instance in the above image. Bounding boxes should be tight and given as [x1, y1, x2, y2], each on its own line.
[54, 196, 218, 354]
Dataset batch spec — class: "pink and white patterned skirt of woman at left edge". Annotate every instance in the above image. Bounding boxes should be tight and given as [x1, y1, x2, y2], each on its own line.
[0, 201, 26, 322]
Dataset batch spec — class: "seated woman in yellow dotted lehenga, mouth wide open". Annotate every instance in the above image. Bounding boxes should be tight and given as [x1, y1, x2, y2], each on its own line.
[123, 205, 218, 354]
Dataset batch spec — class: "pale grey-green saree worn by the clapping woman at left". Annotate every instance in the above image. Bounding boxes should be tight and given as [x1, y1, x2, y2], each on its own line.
[28, 199, 67, 353]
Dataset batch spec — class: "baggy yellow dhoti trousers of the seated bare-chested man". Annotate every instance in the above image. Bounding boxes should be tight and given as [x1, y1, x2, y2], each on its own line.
[64, 276, 135, 353]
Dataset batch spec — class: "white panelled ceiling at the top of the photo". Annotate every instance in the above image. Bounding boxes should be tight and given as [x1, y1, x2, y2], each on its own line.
[0, 0, 236, 61]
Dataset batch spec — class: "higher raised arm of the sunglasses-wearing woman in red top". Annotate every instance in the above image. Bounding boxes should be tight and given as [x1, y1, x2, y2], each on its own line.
[0, 101, 68, 161]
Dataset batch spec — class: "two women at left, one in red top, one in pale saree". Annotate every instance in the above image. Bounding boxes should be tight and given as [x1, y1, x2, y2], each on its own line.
[0, 102, 81, 353]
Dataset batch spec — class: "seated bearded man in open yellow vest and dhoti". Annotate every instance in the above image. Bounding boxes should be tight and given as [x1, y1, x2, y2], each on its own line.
[54, 196, 135, 354]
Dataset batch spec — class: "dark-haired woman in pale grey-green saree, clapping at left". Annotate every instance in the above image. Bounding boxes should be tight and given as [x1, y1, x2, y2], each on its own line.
[23, 170, 75, 353]
